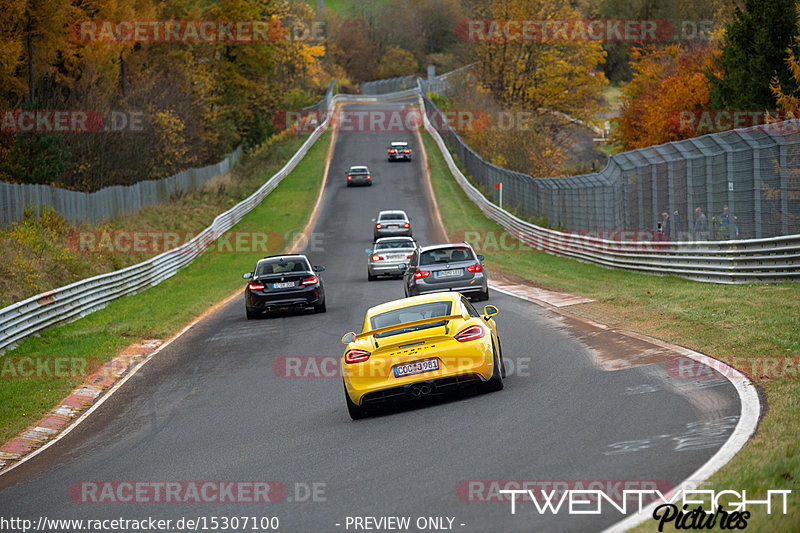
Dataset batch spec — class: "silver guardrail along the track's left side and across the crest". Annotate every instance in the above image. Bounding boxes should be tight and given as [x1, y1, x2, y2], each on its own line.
[0, 85, 416, 351]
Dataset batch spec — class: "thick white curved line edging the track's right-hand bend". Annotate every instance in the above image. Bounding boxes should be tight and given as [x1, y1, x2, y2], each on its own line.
[492, 285, 761, 533]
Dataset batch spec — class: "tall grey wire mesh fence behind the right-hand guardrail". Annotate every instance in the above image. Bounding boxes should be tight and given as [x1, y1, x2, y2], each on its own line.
[419, 79, 800, 241]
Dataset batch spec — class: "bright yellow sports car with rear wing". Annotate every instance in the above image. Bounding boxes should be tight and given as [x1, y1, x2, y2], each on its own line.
[342, 292, 505, 420]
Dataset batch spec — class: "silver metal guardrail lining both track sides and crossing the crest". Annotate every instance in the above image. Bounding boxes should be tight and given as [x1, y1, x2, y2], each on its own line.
[0, 79, 800, 350]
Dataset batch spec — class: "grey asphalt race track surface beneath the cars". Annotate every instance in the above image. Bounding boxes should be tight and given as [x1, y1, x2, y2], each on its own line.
[0, 101, 740, 533]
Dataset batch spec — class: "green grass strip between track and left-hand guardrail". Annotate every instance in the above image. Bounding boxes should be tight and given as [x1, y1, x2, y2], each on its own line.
[0, 133, 330, 442]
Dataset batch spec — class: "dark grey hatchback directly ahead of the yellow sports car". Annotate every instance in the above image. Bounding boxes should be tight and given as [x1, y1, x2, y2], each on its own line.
[403, 242, 489, 300]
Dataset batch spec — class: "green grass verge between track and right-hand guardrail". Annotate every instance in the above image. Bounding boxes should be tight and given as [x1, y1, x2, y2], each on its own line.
[423, 133, 800, 532]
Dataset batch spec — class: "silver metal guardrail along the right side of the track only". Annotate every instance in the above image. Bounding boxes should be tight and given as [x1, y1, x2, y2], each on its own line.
[420, 84, 800, 283]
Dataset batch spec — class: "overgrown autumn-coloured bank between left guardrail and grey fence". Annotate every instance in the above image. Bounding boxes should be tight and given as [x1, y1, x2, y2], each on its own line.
[0, 136, 306, 308]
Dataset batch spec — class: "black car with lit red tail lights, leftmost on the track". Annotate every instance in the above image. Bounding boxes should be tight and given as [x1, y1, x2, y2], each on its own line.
[242, 254, 325, 319]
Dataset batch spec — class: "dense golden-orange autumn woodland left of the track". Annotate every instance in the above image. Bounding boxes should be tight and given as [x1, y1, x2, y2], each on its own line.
[0, 0, 329, 190]
